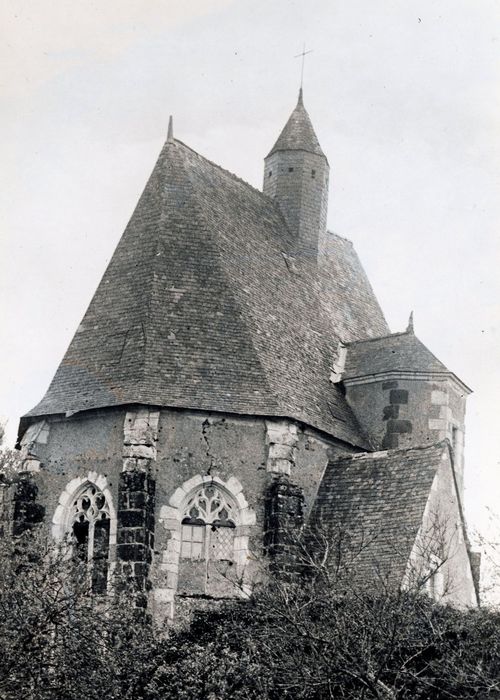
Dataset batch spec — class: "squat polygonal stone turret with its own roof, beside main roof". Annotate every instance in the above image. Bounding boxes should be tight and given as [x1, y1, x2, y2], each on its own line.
[334, 322, 471, 494]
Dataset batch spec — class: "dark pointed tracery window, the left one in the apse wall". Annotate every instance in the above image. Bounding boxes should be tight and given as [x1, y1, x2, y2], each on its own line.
[70, 484, 110, 593]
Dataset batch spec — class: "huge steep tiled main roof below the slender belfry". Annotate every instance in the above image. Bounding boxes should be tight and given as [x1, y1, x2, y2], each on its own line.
[23, 138, 387, 446]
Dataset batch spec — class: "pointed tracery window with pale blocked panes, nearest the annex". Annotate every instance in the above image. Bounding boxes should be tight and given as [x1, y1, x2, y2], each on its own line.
[181, 483, 236, 561]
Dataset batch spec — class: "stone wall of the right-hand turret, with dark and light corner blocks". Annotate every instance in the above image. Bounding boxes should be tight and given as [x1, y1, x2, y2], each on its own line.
[346, 378, 466, 493]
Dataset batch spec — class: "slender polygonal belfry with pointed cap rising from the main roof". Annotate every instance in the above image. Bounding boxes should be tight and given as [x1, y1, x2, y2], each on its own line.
[263, 88, 330, 260]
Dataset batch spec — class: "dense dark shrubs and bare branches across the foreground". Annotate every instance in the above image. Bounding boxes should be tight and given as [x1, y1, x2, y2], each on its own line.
[0, 530, 500, 700]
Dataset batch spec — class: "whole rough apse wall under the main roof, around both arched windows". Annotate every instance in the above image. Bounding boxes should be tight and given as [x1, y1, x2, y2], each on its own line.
[15, 406, 358, 621]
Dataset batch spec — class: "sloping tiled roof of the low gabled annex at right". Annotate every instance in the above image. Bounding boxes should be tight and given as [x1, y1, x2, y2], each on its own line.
[311, 442, 449, 582]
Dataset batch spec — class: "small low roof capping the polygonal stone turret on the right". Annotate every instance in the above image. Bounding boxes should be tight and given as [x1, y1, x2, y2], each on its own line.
[343, 330, 470, 392]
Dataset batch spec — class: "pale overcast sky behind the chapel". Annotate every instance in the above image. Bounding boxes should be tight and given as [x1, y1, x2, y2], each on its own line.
[0, 0, 500, 552]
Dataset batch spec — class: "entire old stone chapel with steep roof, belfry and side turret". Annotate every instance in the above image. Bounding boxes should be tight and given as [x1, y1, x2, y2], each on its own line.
[13, 90, 478, 621]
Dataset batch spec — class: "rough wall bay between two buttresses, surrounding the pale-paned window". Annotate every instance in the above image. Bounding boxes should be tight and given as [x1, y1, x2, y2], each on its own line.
[153, 409, 266, 619]
